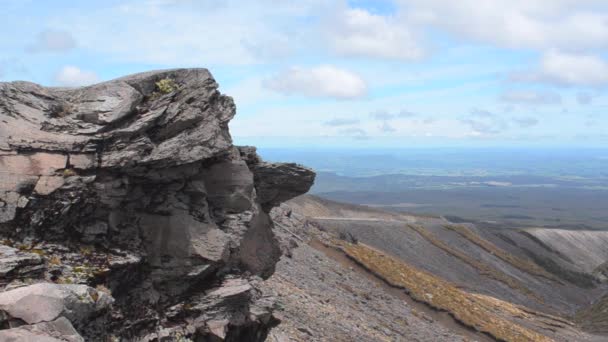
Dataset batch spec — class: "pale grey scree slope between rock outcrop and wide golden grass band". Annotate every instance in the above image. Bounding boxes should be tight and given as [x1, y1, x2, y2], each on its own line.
[264, 206, 475, 341]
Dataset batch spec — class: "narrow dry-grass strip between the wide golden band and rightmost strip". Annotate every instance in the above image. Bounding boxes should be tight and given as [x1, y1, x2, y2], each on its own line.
[408, 225, 543, 303]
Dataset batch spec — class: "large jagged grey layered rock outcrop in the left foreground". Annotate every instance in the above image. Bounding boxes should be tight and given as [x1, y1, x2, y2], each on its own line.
[0, 69, 314, 341]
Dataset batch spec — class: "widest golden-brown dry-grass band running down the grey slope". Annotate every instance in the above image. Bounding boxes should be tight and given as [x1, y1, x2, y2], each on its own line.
[335, 241, 552, 342]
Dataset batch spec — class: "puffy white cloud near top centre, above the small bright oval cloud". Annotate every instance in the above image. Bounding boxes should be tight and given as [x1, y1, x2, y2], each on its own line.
[324, 9, 425, 60]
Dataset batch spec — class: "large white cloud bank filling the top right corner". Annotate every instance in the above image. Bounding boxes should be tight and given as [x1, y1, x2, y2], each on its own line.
[399, 0, 608, 49]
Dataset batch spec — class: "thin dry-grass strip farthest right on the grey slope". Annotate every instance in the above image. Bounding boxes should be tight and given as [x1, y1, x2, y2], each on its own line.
[444, 225, 561, 284]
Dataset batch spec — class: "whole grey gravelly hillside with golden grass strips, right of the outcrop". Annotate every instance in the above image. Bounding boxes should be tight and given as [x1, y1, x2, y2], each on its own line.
[266, 195, 606, 341]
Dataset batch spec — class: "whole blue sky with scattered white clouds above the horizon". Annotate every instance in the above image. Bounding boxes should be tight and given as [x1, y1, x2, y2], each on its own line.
[0, 0, 608, 148]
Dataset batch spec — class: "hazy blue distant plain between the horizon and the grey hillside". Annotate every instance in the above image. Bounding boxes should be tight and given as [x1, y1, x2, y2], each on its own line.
[260, 148, 608, 229]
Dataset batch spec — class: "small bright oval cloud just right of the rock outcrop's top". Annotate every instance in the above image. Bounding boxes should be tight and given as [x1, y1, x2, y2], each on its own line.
[263, 65, 367, 99]
